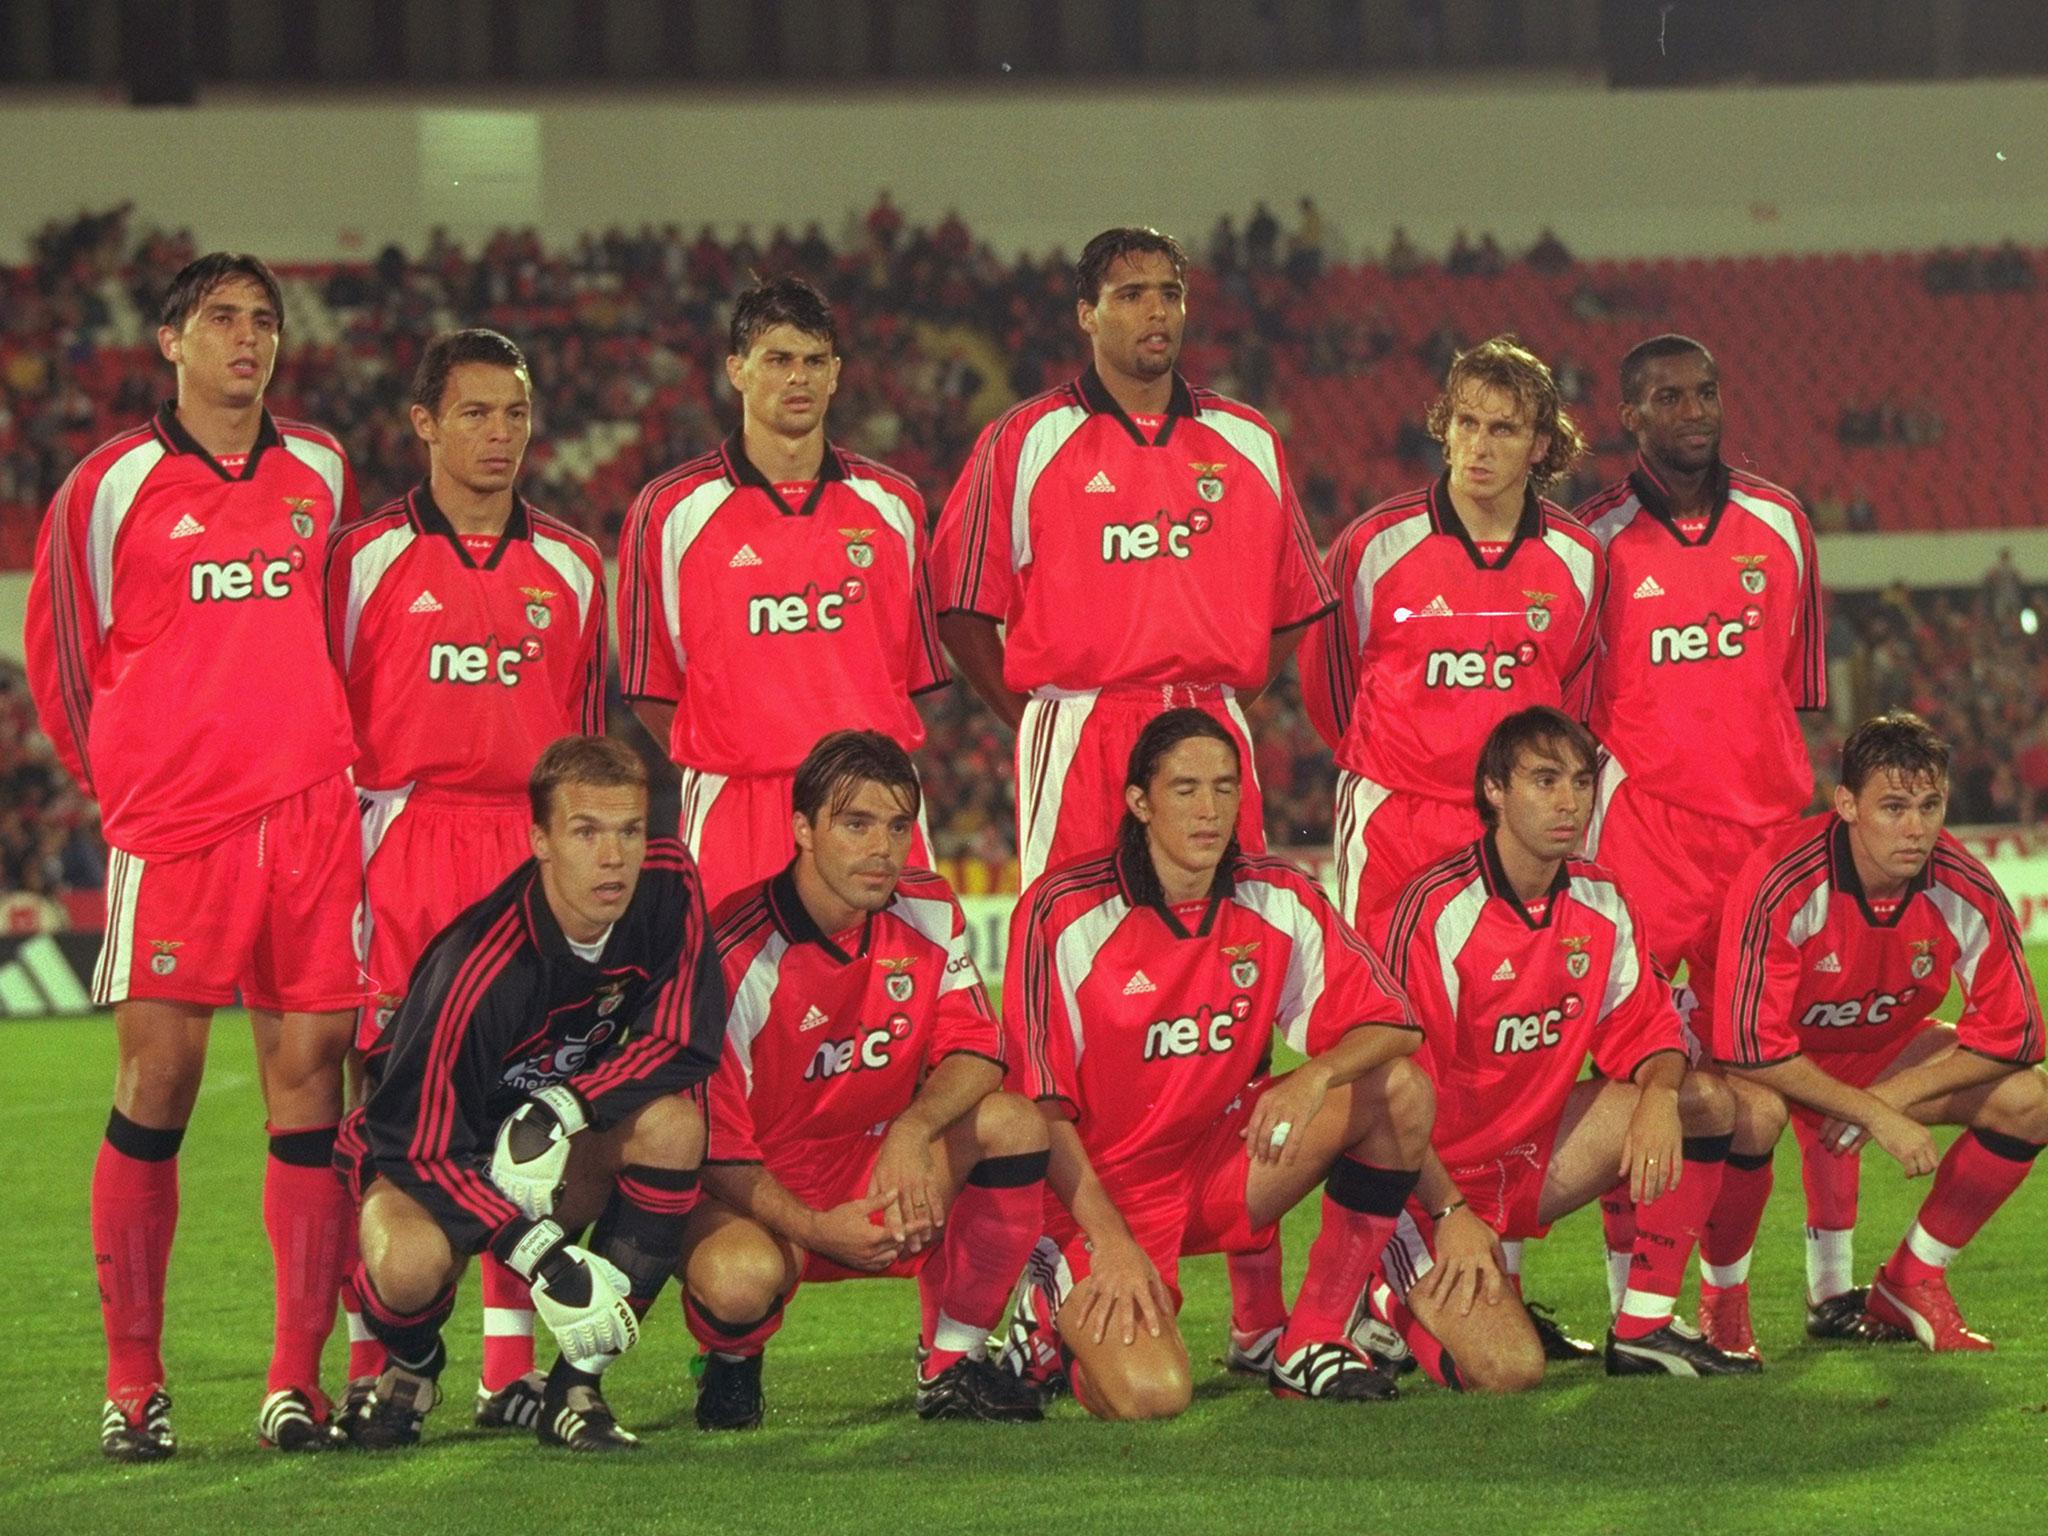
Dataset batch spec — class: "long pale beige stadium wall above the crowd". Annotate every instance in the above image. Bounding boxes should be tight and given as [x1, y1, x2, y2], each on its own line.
[0, 76, 2048, 260]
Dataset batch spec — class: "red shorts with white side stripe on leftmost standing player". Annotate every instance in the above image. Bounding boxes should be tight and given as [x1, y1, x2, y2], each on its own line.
[92, 774, 362, 1014]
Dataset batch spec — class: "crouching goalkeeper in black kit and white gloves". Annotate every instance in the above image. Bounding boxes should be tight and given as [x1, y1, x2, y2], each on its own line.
[336, 737, 725, 1450]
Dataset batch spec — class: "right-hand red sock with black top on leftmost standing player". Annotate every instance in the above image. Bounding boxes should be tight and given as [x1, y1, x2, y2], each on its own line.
[262, 1124, 356, 1401]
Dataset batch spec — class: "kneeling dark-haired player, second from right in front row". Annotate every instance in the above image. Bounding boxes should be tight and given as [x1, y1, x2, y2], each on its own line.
[1374, 707, 1757, 1393]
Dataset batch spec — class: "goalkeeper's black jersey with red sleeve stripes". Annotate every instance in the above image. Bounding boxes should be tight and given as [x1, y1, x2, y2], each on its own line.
[348, 840, 725, 1253]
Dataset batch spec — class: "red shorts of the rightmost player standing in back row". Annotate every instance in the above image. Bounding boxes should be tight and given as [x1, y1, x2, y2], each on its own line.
[1585, 758, 1796, 1040]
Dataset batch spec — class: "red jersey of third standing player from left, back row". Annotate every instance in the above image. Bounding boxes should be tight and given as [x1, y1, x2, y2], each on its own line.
[618, 434, 950, 774]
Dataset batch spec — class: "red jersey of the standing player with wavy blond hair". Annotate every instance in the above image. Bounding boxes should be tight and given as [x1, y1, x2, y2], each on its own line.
[1300, 477, 1606, 801]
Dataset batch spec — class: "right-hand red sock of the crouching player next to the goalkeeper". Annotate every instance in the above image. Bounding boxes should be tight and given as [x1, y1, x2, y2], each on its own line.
[920, 1151, 1049, 1376]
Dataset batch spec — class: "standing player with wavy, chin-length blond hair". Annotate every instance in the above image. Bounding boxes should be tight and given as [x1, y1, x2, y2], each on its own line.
[1300, 336, 1606, 930]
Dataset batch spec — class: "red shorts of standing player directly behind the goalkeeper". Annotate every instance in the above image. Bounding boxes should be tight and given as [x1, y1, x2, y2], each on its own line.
[356, 788, 532, 1051]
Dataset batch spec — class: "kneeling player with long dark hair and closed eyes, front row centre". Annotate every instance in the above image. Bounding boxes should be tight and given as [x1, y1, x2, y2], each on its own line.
[1004, 709, 1432, 1419]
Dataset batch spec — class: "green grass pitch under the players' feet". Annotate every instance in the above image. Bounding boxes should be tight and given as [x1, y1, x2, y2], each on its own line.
[0, 962, 2048, 1536]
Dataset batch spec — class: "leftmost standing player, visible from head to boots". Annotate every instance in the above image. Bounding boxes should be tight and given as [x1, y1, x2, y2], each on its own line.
[25, 252, 362, 1460]
